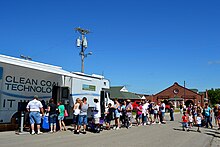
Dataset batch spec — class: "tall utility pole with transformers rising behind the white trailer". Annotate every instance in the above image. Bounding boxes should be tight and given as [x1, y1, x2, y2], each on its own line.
[75, 27, 92, 73]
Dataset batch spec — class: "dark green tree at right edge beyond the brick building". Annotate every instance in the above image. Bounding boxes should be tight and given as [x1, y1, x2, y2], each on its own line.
[208, 88, 220, 105]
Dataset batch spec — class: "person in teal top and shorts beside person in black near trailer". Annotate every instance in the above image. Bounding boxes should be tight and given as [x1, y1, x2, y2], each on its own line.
[57, 102, 67, 131]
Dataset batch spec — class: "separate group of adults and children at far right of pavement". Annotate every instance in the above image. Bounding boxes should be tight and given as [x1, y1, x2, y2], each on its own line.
[180, 103, 220, 132]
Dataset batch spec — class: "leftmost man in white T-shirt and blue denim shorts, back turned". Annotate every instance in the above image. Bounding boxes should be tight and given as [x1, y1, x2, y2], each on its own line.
[26, 95, 44, 135]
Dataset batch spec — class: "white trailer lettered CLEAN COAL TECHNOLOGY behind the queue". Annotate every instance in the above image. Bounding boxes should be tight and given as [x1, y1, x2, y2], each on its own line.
[0, 55, 112, 123]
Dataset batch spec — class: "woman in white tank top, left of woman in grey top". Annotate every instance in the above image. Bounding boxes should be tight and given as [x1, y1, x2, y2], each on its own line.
[73, 98, 80, 134]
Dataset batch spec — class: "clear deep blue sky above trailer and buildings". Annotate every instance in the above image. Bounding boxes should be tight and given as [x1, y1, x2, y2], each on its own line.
[0, 0, 220, 94]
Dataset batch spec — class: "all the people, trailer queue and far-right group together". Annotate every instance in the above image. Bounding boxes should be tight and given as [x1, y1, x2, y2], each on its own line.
[26, 96, 220, 135]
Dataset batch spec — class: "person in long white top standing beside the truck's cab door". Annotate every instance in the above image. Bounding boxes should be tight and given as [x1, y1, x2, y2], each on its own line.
[93, 97, 101, 133]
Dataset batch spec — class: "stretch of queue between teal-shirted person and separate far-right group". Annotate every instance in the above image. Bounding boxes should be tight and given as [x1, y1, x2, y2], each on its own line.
[73, 97, 174, 134]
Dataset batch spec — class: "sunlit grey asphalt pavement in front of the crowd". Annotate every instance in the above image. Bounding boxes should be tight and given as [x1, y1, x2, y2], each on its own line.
[0, 114, 220, 147]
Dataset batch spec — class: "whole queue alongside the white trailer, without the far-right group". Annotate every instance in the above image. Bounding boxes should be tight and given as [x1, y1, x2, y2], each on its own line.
[26, 96, 170, 135]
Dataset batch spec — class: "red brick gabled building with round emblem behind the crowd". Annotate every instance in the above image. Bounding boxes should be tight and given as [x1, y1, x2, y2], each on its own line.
[152, 82, 204, 107]
